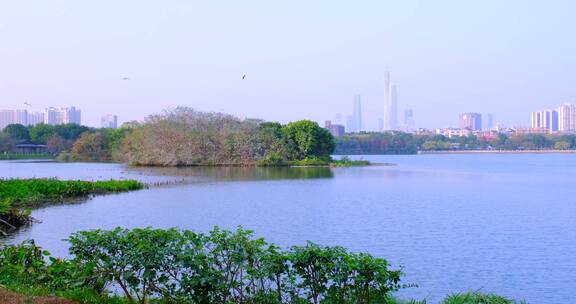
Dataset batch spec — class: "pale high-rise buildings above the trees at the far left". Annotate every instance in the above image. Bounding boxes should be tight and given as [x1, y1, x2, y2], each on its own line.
[0, 107, 82, 129]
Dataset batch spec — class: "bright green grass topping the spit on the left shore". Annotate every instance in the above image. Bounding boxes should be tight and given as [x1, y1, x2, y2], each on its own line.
[0, 178, 144, 208]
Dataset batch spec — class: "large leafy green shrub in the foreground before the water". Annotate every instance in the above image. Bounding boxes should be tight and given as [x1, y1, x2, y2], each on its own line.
[69, 228, 403, 303]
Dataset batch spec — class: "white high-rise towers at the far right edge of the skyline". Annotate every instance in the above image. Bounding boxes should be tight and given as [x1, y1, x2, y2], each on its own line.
[530, 103, 576, 133]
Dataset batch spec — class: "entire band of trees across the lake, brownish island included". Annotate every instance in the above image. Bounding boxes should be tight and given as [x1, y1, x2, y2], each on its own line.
[5, 107, 576, 160]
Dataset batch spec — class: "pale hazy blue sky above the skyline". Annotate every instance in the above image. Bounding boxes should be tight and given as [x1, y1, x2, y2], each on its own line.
[0, 0, 576, 130]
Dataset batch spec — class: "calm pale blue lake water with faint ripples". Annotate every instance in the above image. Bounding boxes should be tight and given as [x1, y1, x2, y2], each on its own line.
[0, 154, 576, 303]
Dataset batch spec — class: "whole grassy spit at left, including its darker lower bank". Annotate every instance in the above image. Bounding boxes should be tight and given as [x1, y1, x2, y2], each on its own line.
[0, 178, 145, 235]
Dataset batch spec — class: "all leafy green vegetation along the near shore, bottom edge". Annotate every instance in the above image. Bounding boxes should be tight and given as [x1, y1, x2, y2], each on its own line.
[0, 227, 519, 304]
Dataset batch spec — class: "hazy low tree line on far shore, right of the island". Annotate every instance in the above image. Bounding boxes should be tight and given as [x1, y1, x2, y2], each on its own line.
[334, 131, 576, 155]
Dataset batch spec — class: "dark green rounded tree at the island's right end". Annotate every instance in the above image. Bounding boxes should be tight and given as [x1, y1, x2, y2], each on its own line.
[282, 120, 335, 160]
